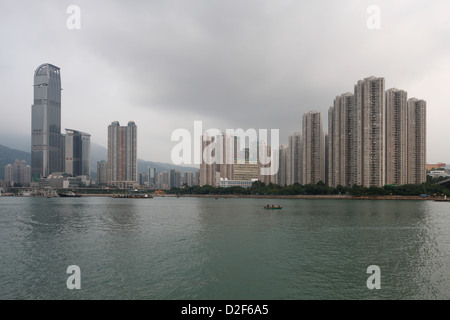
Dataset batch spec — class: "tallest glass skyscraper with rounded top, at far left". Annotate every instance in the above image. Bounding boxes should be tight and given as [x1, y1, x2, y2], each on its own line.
[31, 63, 64, 179]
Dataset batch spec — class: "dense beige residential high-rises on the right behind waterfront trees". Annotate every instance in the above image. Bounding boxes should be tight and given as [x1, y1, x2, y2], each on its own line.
[200, 77, 426, 187]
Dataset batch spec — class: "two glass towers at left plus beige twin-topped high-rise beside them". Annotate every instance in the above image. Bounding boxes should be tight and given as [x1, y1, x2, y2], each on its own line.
[25, 64, 141, 187]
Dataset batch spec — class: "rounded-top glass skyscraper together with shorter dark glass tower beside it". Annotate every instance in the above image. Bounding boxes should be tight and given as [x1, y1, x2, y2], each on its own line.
[31, 64, 91, 183]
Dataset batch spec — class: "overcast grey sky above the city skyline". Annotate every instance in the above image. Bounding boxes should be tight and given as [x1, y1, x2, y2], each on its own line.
[0, 0, 450, 163]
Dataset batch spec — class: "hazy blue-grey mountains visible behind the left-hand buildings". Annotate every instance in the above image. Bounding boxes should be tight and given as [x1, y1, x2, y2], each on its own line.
[0, 143, 198, 180]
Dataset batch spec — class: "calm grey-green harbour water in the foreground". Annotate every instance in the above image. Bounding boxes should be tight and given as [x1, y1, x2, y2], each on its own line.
[0, 197, 450, 300]
